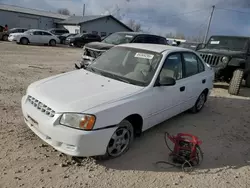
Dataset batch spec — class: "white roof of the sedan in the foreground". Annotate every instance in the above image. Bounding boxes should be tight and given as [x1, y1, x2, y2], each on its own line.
[118, 43, 193, 53]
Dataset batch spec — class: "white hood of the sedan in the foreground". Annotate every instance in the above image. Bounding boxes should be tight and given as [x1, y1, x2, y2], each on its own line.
[27, 69, 143, 112]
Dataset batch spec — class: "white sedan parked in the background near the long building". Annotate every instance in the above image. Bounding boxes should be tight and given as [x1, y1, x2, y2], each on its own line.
[15, 29, 60, 46]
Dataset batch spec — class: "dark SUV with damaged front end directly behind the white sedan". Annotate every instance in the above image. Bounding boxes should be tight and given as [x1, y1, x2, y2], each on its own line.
[75, 32, 168, 69]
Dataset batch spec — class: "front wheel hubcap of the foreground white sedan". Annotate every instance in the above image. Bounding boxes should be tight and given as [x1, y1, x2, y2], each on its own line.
[108, 128, 131, 157]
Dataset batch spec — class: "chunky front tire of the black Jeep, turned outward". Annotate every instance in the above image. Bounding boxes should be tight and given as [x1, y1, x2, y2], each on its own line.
[228, 69, 244, 95]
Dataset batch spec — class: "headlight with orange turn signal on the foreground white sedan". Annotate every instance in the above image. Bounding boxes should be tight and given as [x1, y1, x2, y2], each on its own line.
[60, 113, 95, 131]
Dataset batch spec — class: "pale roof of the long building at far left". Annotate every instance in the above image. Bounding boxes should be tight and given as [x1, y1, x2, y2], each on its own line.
[0, 4, 69, 20]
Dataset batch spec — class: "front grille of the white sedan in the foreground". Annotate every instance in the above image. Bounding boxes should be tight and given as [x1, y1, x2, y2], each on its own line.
[27, 95, 55, 117]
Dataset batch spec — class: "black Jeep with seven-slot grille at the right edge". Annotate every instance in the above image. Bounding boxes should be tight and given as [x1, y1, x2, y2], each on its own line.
[198, 35, 250, 95]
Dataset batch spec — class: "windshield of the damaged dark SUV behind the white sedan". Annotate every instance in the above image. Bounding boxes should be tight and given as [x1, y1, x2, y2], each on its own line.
[102, 33, 134, 45]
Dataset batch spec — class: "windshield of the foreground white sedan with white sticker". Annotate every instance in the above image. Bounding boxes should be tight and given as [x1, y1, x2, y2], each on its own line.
[87, 47, 162, 86]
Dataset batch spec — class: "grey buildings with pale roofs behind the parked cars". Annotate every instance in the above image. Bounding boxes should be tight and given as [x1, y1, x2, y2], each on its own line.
[0, 4, 132, 36]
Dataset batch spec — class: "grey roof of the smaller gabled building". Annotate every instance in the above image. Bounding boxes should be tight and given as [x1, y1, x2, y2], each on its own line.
[57, 15, 133, 31]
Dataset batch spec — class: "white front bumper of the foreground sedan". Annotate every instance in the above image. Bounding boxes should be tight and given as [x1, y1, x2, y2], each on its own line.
[22, 96, 116, 157]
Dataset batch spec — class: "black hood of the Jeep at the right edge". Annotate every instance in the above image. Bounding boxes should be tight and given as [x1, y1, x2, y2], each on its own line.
[198, 48, 246, 56]
